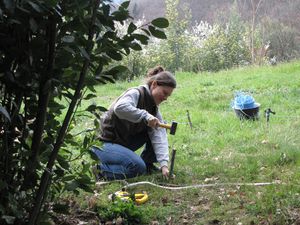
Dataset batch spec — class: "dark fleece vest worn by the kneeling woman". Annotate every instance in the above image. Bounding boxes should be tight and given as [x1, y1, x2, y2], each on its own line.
[100, 86, 158, 147]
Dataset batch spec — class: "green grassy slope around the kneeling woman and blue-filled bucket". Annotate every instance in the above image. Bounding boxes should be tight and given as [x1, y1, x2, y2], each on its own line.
[75, 61, 300, 224]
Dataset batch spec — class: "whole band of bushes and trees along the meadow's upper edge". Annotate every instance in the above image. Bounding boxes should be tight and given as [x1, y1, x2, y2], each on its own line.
[112, 0, 300, 77]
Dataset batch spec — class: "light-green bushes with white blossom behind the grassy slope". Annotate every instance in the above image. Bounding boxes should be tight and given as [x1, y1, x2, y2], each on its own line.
[112, 1, 251, 76]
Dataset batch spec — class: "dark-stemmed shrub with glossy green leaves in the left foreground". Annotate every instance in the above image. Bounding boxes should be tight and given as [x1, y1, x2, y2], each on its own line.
[0, 0, 168, 224]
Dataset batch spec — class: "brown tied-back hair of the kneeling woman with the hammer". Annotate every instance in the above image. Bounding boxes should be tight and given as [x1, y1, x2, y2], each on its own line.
[146, 66, 176, 88]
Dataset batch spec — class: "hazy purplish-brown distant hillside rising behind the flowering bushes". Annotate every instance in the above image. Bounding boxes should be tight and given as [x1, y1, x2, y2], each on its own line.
[130, 0, 300, 30]
